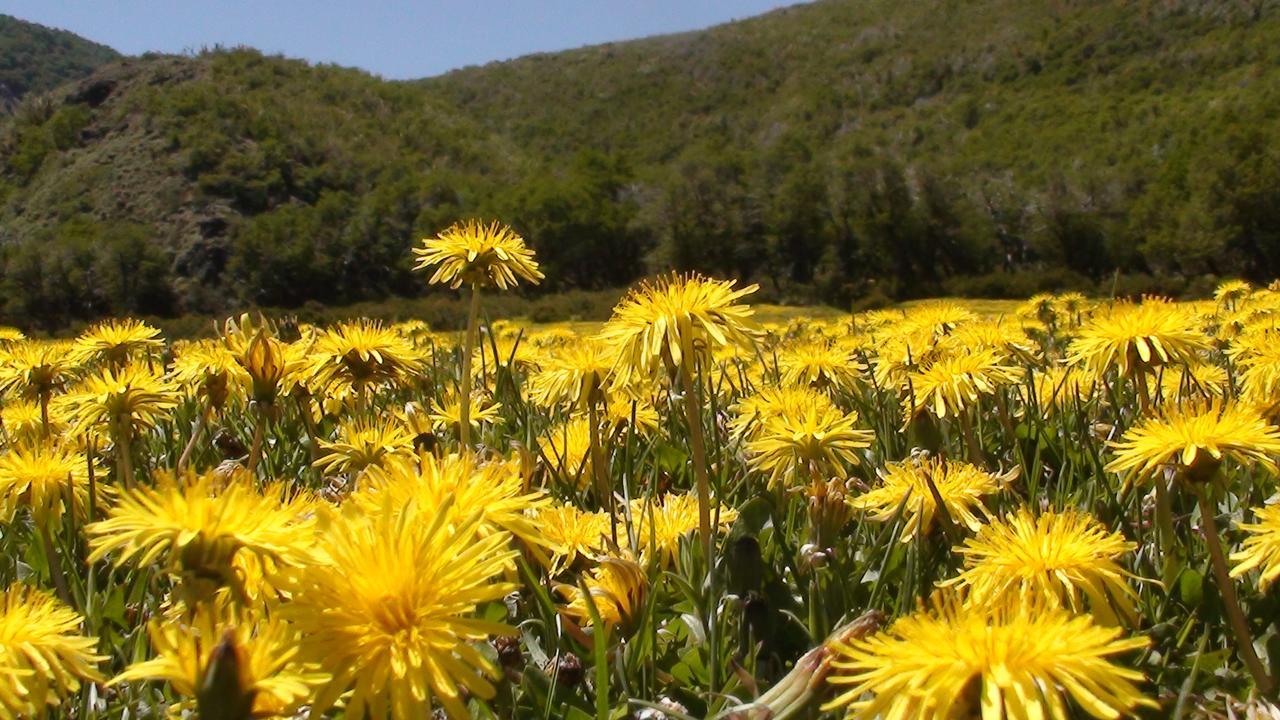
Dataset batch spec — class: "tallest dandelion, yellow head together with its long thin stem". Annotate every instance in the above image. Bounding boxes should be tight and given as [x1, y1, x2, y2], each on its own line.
[413, 220, 544, 447]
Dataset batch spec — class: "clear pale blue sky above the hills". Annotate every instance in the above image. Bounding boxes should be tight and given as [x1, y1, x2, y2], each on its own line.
[0, 0, 794, 78]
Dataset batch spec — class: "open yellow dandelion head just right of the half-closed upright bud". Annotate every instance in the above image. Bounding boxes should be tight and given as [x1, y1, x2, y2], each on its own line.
[310, 320, 422, 395]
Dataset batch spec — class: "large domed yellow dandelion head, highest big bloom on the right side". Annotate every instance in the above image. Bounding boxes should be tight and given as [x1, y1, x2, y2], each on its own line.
[1069, 300, 1210, 377]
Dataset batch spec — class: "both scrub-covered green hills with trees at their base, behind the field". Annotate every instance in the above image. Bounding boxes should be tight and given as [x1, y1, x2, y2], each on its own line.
[0, 0, 1280, 328]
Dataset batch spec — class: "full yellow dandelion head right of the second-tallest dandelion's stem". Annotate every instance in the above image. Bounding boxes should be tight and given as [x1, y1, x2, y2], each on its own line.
[746, 405, 876, 487]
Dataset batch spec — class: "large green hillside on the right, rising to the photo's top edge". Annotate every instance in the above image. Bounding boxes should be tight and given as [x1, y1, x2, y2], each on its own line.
[425, 0, 1280, 284]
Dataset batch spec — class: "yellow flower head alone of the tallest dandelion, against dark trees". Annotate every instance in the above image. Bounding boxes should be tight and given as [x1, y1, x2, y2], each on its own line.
[413, 220, 544, 290]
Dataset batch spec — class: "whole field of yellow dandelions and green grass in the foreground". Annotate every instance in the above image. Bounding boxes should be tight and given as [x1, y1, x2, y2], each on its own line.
[0, 224, 1280, 720]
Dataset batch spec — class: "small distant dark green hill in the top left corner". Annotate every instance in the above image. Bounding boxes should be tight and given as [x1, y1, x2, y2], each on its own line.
[0, 15, 119, 111]
